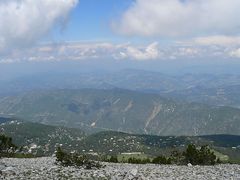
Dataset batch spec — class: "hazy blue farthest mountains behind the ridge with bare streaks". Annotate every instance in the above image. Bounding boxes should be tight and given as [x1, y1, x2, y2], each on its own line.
[0, 69, 240, 108]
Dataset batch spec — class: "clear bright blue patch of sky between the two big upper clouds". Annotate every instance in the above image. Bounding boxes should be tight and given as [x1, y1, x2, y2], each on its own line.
[54, 0, 132, 41]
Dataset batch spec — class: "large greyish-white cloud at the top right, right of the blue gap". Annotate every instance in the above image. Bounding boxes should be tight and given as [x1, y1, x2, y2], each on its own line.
[113, 0, 240, 36]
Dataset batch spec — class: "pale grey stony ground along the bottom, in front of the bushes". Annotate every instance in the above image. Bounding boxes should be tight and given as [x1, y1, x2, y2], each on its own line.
[0, 157, 240, 180]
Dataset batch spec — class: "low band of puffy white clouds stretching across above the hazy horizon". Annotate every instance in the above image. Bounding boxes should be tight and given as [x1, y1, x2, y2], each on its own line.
[0, 42, 240, 64]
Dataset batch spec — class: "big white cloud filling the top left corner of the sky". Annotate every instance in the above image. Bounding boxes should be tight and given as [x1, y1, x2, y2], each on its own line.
[0, 0, 78, 52]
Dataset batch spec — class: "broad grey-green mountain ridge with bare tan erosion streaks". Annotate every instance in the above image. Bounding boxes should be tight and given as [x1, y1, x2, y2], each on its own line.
[0, 89, 240, 136]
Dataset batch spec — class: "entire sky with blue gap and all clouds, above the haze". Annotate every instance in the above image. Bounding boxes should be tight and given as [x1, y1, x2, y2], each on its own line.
[0, 0, 240, 66]
